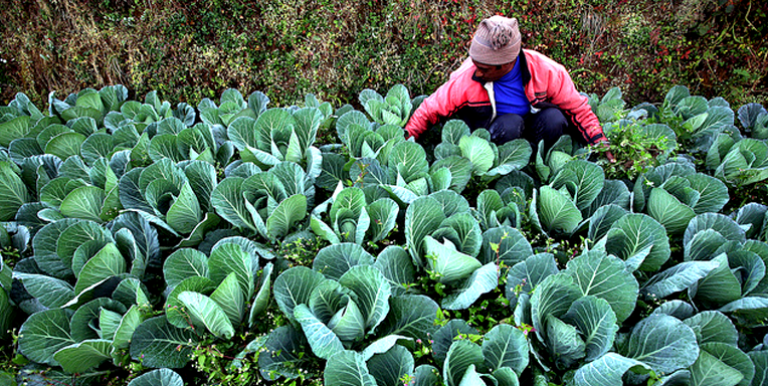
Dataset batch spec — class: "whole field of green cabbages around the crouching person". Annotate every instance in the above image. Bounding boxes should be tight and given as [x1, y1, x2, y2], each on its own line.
[0, 85, 768, 386]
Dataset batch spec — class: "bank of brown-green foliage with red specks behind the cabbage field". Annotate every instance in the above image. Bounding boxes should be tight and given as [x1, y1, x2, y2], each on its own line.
[0, 0, 768, 105]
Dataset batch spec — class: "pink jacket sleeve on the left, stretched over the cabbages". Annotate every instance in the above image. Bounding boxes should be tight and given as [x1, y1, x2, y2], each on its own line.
[405, 78, 467, 138]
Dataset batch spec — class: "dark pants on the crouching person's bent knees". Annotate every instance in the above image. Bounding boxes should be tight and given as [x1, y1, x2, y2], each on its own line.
[488, 107, 568, 150]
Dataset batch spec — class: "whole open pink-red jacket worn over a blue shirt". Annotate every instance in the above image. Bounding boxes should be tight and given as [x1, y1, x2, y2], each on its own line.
[405, 49, 608, 144]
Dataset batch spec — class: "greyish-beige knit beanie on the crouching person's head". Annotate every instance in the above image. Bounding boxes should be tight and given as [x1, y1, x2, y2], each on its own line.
[469, 16, 520, 66]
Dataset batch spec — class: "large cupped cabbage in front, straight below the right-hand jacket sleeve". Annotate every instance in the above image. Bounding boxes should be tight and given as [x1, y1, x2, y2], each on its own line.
[507, 251, 639, 368]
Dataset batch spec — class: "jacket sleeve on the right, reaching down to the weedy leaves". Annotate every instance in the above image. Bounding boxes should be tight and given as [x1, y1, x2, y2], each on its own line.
[548, 66, 608, 145]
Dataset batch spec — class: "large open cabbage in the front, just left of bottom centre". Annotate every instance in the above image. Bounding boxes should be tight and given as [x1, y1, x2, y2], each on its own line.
[259, 243, 438, 379]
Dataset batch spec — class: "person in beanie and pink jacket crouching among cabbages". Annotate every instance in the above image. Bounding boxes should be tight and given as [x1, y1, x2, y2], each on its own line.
[405, 16, 613, 161]
